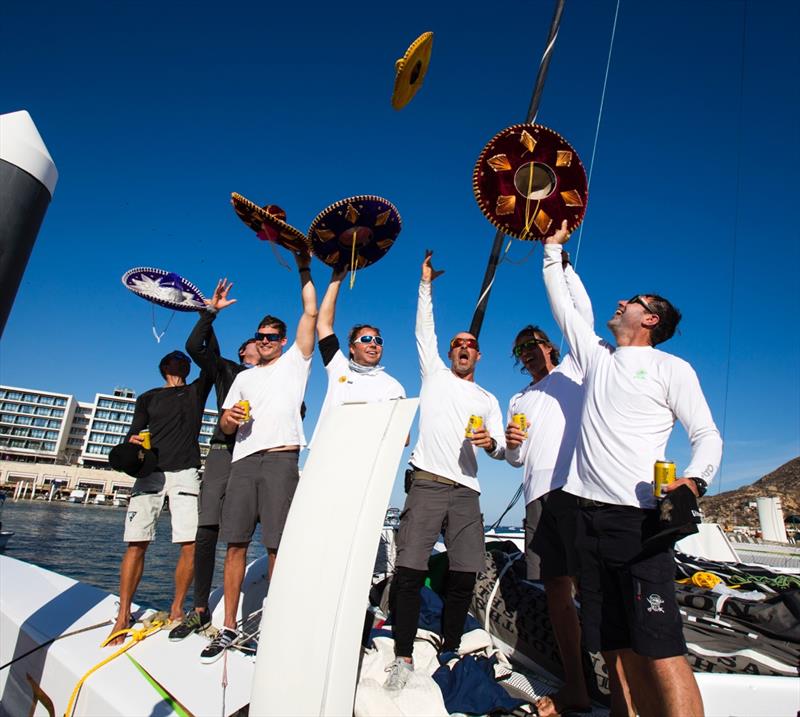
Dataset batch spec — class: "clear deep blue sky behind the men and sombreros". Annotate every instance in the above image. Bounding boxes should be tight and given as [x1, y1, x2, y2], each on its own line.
[0, 0, 800, 522]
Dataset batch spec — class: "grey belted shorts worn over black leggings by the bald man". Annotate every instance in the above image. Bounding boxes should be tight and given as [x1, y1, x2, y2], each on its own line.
[395, 471, 485, 573]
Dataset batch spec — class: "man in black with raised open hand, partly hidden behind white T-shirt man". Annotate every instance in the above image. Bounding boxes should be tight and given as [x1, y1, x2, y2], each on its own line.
[169, 279, 259, 641]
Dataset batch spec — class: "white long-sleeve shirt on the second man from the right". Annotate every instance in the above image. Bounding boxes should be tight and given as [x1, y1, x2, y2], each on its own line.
[506, 265, 594, 504]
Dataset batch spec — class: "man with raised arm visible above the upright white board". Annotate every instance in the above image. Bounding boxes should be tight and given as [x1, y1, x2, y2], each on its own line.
[312, 269, 406, 445]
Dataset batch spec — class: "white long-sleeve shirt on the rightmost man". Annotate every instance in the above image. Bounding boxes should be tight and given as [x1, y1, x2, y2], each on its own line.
[544, 244, 722, 508]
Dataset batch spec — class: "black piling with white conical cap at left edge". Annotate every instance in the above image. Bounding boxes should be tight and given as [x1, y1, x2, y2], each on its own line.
[0, 111, 58, 336]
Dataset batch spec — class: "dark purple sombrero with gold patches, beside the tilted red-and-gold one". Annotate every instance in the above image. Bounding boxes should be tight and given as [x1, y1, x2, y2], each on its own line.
[308, 194, 403, 269]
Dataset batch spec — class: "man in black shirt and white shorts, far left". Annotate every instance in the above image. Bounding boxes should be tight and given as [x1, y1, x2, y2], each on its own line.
[109, 351, 214, 645]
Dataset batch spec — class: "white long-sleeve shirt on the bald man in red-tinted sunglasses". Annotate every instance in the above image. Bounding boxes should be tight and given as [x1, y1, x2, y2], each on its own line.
[411, 281, 505, 492]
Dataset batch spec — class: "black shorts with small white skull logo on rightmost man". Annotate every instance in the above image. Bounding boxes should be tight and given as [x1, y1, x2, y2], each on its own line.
[577, 504, 686, 658]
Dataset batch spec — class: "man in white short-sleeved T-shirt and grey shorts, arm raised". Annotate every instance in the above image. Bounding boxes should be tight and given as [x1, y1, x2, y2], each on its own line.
[200, 253, 317, 663]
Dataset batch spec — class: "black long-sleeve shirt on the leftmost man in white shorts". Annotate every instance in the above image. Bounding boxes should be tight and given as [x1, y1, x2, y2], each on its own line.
[127, 371, 214, 471]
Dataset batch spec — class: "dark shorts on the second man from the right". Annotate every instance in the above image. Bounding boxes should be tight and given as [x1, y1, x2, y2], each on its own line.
[525, 488, 578, 580]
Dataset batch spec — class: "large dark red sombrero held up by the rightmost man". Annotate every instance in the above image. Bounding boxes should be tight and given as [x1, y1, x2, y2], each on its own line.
[472, 124, 588, 241]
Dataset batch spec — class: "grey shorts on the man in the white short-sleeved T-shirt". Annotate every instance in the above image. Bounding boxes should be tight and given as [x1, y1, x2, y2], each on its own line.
[219, 451, 300, 550]
